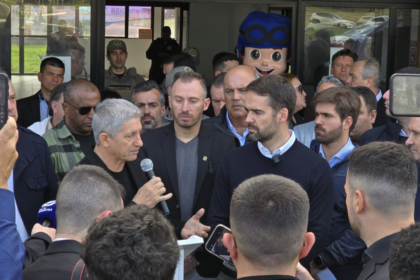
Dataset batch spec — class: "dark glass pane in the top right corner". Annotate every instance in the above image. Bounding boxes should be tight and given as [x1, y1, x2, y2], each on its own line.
[394, 9, 420, 72]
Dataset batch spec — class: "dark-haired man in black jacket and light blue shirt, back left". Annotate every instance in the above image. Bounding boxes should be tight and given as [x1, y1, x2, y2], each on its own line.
[17, 57, 64, 127]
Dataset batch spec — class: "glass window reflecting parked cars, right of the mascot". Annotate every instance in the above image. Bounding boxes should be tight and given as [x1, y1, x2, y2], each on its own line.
[303, 7, 389, 90]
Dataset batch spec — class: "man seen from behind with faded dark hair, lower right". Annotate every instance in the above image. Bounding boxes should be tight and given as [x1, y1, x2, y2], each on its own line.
[344, 142, 417, 280]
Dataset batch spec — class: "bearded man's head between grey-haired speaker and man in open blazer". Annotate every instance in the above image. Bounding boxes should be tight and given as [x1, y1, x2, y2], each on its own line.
[131, 80, 165, 134]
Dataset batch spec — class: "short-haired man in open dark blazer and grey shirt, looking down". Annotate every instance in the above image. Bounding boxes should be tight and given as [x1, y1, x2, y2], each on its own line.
[140, 71, 235, 278]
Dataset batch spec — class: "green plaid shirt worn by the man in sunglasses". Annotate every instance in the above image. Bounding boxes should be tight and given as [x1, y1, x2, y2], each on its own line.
[42, 118, 85, 186]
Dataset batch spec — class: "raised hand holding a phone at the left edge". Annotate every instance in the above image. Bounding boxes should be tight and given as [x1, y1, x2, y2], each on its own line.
[0, 117, 19, 190]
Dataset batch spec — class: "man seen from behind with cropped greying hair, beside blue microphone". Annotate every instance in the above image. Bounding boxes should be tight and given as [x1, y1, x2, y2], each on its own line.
[23, 165, 125, 280]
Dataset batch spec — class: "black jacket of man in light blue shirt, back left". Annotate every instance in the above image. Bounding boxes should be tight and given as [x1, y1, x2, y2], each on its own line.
[16, 90, 41, 127]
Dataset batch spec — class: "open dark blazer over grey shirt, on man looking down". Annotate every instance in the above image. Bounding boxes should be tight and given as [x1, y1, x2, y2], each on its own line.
[139, 123, 235, 237]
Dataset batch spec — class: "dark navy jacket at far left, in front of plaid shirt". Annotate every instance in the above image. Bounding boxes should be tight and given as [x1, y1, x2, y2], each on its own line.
[13, 126, 58, 233]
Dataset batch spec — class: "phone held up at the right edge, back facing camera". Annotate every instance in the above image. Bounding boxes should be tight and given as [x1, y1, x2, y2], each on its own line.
[389, 74, 420, 117]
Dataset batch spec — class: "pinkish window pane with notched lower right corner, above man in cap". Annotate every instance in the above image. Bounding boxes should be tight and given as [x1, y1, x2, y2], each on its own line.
[128, 6, 152, 38]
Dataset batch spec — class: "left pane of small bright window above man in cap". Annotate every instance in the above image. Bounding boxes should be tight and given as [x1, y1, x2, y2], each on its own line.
[105, 6, 125, 37]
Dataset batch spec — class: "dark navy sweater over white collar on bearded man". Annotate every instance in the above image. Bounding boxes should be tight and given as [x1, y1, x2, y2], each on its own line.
[207, 141, 334, 265]
